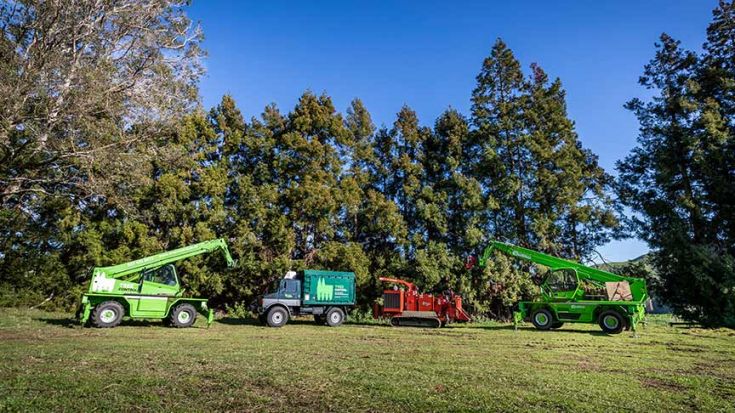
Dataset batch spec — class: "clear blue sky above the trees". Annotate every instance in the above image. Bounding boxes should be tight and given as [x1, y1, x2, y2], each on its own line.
[188, 0, 717, 261]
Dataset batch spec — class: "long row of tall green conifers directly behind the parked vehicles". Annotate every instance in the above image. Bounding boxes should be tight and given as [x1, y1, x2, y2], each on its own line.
[0, 39, 614, 317]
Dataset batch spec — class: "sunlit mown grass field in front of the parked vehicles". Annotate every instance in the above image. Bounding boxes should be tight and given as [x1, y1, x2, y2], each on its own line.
[0, 309, 735, 412]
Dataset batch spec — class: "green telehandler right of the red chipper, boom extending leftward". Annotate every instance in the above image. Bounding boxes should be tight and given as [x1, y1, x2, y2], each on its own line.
[467, 241, 648, 334]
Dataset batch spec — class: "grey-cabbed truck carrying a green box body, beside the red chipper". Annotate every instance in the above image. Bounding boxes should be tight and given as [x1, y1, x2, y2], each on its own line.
[257, 270, 355, 327]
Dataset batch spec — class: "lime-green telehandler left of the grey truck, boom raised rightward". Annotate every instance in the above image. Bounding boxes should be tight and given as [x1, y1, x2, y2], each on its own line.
[77, 239, 235, 328]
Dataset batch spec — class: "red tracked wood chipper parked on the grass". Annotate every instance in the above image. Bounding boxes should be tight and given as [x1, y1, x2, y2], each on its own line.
[373, 277, 470, 327]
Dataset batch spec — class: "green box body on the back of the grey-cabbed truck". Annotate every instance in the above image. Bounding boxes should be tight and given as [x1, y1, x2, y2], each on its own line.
[302, 270, 355, 305]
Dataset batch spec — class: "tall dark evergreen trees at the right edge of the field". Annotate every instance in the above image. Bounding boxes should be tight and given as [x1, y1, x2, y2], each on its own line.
[618, 1, 735, 326]
